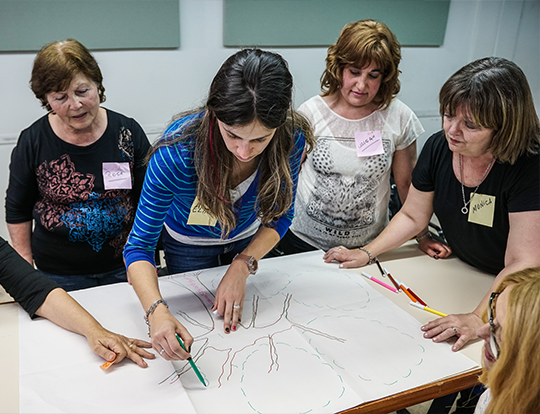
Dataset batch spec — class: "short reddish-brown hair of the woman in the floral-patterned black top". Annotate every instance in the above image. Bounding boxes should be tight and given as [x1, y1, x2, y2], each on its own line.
[30, 39, 105, 111]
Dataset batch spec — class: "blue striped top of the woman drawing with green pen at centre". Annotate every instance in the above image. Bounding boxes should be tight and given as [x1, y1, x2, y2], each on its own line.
[124, 112, 305, 267]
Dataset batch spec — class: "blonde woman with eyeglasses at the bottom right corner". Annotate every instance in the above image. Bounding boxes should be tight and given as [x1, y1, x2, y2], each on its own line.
[475, 267, 540, 414]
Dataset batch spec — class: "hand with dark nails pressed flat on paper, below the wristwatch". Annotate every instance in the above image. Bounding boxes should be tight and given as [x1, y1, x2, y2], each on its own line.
[212, 260, 249, 333]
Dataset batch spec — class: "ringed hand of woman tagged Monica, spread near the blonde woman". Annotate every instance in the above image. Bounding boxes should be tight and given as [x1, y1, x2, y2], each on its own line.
[421, 313, 484, 351]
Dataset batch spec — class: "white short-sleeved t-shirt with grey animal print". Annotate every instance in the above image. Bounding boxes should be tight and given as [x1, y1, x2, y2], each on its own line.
[291, 96, 424, 250]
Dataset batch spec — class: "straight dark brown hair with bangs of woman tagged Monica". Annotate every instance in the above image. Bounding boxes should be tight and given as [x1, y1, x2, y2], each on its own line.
[439, 57, 540, 164]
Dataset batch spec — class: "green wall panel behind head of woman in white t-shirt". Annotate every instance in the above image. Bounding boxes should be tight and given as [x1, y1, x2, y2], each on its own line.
[223, 0, 450, 47]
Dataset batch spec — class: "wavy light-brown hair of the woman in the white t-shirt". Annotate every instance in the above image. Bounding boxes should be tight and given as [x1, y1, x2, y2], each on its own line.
[321, 20, 401, 108]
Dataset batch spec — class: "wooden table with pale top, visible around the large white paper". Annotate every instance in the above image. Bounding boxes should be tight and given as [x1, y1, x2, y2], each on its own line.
[0, 242, 494, 413]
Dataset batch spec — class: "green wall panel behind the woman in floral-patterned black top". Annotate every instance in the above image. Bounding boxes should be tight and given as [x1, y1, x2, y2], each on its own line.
[0, 0, 180, 52]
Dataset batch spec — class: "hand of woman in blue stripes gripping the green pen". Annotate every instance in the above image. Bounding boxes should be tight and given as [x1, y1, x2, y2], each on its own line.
[148, 306, 193, 361]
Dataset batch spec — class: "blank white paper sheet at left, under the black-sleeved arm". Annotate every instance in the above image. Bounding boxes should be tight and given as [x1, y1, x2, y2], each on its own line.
[19, 283, 195, 413]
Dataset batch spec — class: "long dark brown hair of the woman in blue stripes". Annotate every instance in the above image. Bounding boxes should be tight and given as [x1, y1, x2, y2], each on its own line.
[149, 49, 315, 238]
